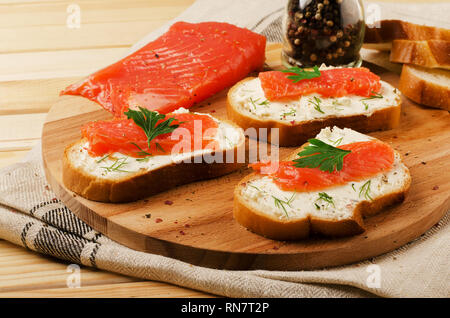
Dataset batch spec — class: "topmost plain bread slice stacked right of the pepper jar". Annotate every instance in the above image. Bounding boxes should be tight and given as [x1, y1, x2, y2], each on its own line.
[364, 20, 450, 51]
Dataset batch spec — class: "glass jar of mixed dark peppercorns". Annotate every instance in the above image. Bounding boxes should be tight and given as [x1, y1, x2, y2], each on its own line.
[282, 0, 364, 67]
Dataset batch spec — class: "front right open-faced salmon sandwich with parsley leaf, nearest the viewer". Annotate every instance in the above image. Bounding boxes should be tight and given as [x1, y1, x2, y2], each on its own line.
[234, 127, 411, 240]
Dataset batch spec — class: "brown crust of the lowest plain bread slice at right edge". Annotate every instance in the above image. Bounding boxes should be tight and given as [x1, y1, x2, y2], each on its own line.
[398, 64, 450, 111]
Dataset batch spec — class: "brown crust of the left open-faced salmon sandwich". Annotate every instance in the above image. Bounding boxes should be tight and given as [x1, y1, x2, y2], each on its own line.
[63, 133, 245, 203]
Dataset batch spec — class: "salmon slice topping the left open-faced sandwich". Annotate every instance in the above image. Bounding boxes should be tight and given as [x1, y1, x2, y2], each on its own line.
[81, 113, 218, 157]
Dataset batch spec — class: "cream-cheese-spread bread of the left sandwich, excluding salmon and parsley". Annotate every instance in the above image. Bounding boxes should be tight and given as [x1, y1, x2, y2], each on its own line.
[63, 115, 245, 202]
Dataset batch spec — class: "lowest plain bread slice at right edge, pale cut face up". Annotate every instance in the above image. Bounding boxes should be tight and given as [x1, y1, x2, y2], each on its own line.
[399, 64, 450, 111]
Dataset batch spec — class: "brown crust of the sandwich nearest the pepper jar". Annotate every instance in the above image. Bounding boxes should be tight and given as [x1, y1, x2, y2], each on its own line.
[227, 77, 401, 147]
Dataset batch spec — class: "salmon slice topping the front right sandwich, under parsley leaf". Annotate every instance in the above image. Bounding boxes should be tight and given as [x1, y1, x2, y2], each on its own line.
[250, 141, 394, 192]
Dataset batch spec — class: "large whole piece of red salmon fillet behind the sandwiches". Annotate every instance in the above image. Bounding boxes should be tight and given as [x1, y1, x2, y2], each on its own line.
[61, 22, 266, 117]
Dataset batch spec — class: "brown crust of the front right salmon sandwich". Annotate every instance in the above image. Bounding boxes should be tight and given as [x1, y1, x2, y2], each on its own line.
[233, 144, 411, 240]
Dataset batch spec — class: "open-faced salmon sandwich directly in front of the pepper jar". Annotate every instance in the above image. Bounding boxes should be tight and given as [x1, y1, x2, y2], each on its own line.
[227, 67, 401, 146]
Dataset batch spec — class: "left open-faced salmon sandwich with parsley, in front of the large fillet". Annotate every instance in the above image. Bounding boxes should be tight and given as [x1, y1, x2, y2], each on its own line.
[63, 108, 245, 202]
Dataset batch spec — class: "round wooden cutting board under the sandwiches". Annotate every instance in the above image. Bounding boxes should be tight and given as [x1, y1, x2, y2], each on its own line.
[42, 45, 450, 270]
